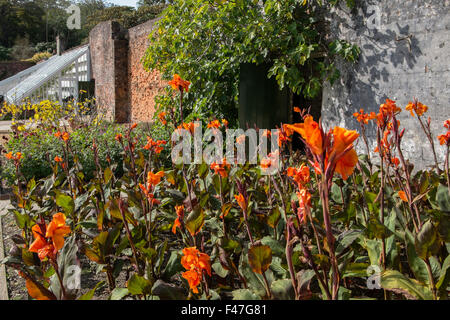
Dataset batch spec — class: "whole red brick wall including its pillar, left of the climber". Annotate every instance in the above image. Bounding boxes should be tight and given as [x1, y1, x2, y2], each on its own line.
[89, 20, 167, 122]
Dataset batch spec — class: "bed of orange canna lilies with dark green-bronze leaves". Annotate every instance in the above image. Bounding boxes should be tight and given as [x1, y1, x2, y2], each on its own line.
[0, 77, 450, 299]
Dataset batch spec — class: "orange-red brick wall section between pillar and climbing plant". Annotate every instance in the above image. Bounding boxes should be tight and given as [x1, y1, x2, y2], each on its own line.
[128, 19, 167, 122]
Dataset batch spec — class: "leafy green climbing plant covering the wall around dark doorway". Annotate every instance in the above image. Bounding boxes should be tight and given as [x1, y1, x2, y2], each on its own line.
[144, 0, 359, 125]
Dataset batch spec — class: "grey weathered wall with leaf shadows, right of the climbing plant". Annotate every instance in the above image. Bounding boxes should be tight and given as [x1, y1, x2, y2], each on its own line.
[322, 0, 450, 168]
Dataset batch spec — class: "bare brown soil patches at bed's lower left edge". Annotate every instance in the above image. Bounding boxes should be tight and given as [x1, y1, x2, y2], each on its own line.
[0, 201, 127, 300]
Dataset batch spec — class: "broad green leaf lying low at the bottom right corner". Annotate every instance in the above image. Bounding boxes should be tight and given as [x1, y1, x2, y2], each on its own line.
[380, 270, 433, 300]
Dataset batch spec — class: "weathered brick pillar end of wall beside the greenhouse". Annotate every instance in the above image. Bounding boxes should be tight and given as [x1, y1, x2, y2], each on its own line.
[89, 21, 129, 122]
